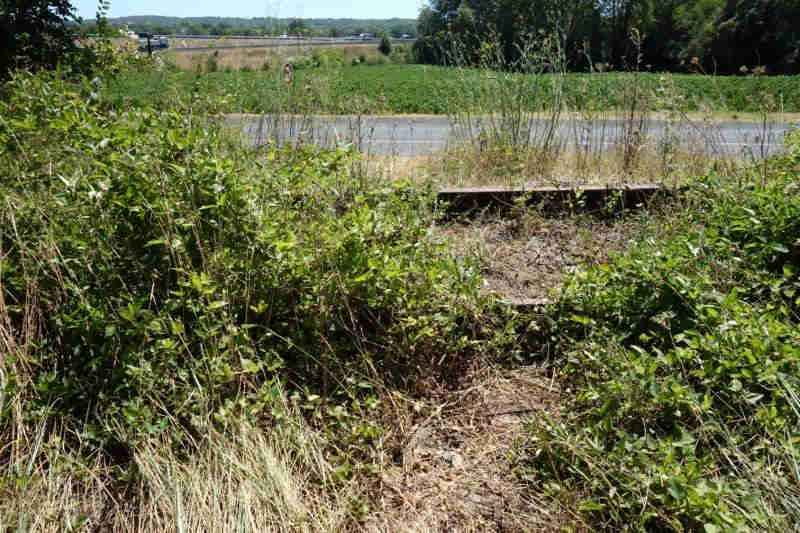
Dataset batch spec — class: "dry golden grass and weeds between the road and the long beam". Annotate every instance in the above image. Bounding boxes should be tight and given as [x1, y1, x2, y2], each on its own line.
[348, 108, 774, 187]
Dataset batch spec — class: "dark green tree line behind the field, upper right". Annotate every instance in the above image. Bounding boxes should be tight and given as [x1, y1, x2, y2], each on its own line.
[415, 0, 800, 74]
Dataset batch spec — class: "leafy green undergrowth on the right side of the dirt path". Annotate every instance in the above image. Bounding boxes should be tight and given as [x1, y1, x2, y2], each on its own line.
[526, 133, 800, 532]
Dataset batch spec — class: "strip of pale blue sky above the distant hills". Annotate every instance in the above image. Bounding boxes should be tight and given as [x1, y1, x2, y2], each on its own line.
[72, 0, 423, 19]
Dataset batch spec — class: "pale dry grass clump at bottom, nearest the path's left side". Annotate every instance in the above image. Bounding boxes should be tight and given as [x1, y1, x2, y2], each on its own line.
[135, 425, 356, 532]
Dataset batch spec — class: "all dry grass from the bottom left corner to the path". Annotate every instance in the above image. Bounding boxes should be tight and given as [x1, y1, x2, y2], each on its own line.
[0, 384, 360, 533]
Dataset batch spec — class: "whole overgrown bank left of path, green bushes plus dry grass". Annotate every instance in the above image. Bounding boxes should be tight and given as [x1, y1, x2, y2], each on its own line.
[0, 69, 514, 531]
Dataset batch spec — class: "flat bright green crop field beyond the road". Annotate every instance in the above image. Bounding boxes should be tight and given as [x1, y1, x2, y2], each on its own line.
[103, 64, 800, 114]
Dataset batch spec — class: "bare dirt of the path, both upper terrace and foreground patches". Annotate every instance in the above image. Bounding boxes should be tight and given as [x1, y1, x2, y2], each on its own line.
[364, 213, 639, 532]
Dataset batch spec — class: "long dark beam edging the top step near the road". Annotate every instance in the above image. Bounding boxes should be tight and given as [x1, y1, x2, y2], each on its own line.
[436, 183, 676, 215]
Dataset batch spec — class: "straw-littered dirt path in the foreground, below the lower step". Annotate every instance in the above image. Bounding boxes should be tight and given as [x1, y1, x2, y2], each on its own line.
[365, 367, 565, 532]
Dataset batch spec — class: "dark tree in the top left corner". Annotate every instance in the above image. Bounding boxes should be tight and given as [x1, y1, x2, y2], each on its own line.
[0, 0, 81, 77]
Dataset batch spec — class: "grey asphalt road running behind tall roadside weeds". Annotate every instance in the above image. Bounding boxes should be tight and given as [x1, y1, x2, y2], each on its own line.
[227, 115, 796, 158]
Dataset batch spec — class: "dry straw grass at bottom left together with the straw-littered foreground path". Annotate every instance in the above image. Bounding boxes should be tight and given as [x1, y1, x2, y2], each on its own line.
[0, 367, 563, 533]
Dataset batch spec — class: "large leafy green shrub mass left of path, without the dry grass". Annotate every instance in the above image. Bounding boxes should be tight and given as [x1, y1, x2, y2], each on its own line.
[0, 70, 504, 462]
